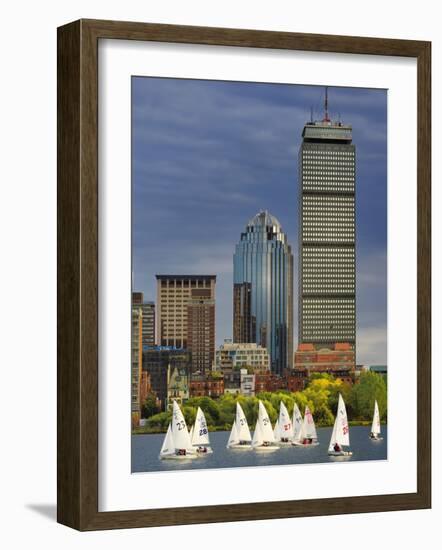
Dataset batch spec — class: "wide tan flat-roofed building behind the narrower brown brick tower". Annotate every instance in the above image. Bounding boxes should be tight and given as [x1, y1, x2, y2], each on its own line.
[156, 275, 216, 349]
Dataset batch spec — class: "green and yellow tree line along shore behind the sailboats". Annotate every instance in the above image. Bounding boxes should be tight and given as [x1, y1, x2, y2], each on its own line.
[132, 372, 387, 434]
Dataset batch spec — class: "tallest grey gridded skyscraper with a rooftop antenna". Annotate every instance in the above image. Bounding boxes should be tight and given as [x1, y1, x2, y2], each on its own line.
[298, 89, 356, 349]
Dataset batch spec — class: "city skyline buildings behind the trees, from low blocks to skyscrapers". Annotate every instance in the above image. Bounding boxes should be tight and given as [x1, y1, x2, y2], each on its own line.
[132, 99, 370, 430]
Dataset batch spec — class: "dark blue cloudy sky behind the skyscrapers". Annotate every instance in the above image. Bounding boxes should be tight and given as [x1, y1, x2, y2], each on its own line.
[132, 77, 387, 364]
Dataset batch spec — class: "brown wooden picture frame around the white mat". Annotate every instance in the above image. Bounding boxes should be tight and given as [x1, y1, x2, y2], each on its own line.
[57, 20, 431, 531]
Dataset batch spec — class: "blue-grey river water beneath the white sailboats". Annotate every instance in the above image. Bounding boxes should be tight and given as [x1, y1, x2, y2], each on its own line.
[132, 425, 388, 472]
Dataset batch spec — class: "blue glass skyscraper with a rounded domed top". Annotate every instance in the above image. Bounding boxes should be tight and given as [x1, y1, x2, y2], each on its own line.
[233, 211, 293, 374]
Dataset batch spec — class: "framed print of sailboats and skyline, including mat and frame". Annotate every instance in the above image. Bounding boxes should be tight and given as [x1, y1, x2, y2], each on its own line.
[58, 20, 431, 530]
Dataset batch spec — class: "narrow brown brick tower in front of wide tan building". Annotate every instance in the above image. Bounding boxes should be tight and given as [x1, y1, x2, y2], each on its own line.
[187, 288, 215, 374]
